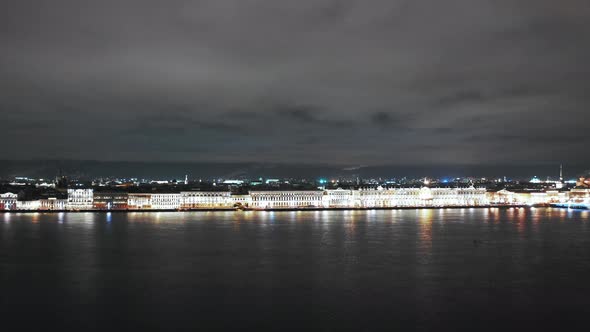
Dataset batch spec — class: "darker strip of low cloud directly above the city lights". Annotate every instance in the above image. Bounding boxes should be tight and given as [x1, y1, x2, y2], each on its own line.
[0, 160, 590, 180]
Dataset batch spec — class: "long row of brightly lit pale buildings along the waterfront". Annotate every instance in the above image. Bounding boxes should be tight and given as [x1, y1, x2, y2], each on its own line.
[0, 186, 590, 211]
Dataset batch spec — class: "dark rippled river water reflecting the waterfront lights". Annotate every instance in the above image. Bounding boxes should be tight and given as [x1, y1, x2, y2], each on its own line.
[0, 209, 590, 331]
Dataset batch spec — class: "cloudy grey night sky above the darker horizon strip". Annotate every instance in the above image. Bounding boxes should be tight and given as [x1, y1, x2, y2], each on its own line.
[0, 0, 590, 165]
